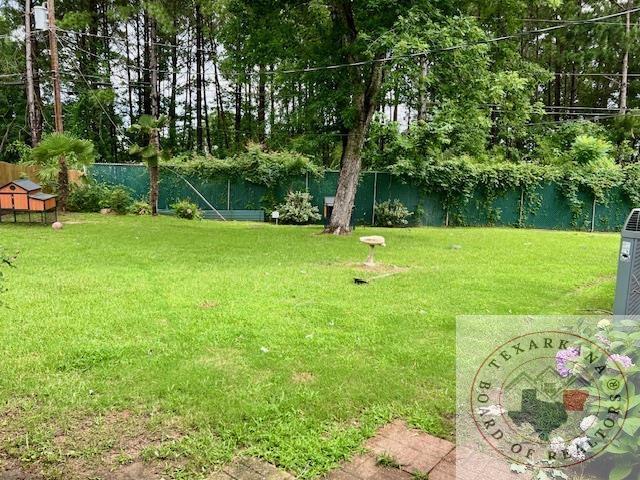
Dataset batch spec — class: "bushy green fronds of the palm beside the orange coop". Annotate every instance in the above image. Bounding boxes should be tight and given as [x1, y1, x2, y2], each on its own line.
[25, 133, 95, 189]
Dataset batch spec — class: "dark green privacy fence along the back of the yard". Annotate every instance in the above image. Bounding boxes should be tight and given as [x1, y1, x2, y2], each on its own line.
[89, 164, 632, 231]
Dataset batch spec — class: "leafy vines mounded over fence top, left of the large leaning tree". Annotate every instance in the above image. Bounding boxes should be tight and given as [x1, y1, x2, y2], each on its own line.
[172, 144, 322, 186]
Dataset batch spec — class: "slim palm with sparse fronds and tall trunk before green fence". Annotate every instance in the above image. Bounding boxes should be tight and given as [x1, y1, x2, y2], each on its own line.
[129, 115, 167, 215]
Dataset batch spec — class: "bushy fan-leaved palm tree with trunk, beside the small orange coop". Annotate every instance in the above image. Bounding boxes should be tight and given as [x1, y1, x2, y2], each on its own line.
[25, 133, 95, 211]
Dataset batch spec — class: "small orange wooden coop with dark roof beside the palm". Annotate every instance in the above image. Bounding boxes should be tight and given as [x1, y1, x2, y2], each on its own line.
[0, 180, 57, 222]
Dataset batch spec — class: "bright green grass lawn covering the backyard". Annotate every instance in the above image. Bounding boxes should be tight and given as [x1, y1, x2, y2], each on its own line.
[0, 215, 619, 478]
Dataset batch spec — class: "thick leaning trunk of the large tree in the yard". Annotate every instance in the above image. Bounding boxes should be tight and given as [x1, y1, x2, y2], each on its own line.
[325, 63, 383, 235]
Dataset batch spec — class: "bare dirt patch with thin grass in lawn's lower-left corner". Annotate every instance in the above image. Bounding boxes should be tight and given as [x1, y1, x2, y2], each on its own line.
[0, 410, 183, 480]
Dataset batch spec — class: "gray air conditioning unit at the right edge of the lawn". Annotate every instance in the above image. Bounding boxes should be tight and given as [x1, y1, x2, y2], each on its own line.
[613, 208, 640, 316]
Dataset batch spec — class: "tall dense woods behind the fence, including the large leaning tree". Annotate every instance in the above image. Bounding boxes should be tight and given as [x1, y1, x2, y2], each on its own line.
[0, 0, 640, 230]
